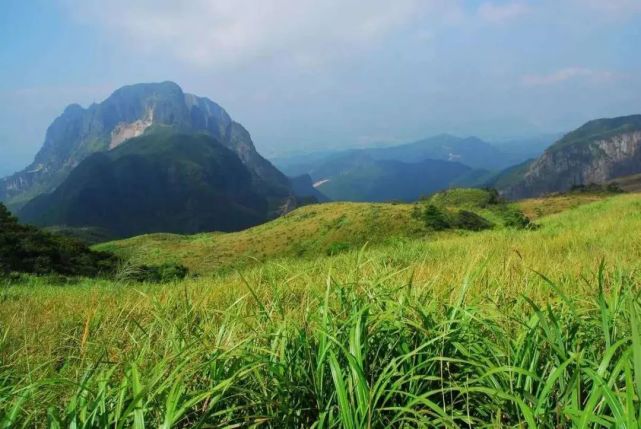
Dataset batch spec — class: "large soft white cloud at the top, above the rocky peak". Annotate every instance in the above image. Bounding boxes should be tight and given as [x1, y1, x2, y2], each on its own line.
[68, 0, 444, 67]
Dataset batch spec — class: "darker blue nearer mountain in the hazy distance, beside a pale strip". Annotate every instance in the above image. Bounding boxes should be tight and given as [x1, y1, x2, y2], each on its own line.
[312, 151, 475, 201]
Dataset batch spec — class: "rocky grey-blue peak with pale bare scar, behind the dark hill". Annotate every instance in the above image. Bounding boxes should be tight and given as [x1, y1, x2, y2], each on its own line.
[0, 82, 293, 213]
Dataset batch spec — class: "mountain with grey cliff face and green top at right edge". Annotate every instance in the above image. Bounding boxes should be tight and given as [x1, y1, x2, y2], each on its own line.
[494, 115, 641, 199]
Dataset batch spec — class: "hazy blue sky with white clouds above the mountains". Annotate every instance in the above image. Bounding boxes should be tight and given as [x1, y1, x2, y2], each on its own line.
[0, 0, 641, 176]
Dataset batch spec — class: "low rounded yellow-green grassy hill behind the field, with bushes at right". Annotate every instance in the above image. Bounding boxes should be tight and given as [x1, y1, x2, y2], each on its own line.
[96, 189, 552, 274]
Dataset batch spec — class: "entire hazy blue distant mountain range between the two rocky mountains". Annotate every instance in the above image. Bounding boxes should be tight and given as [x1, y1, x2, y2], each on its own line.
[273, 134, 553, 201]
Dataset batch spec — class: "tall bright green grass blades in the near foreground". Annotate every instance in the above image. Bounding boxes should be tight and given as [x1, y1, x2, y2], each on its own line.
[0, 260, 641, 428]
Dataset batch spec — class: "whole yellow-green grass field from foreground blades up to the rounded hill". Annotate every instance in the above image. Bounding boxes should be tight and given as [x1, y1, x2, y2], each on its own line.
[0, 195, 641, 428]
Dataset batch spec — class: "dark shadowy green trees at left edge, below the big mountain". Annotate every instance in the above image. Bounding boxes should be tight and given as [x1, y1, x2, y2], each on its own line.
[0, 203, 117, 276]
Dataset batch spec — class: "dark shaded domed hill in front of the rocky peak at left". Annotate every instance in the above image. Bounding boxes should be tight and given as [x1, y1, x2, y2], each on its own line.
[19, 132, 278, 237]
